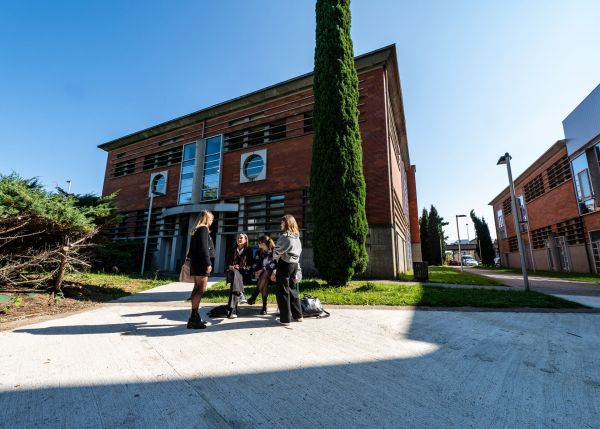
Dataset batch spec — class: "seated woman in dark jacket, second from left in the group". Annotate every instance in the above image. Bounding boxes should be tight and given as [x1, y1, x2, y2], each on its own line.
[227, 232, 252, 319]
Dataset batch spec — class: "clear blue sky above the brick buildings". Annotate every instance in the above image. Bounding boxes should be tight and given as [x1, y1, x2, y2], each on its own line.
[0, 0, 600, 239]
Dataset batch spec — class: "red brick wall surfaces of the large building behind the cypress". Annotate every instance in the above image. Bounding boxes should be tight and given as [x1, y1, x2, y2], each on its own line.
[102, 68, 394, 224]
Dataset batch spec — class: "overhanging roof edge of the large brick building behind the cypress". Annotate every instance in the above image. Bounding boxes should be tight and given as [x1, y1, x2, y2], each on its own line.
[98, 44, 396, 152]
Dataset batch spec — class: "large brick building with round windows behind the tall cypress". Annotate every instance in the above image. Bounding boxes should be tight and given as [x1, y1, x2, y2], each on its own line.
[99, 45, 421, 278]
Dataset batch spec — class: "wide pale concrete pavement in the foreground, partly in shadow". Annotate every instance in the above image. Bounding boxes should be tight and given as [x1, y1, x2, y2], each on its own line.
[0, 283, 600, 429]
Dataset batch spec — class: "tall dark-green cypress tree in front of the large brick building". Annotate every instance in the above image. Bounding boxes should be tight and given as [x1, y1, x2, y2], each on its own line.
[310, 0, 368, 285]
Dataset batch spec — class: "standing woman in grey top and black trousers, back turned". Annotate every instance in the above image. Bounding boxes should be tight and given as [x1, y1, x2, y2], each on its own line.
[273, 215, 302, 325]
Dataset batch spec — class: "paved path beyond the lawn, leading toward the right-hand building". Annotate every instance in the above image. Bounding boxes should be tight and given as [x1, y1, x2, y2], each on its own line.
[465, 268, 600, 308]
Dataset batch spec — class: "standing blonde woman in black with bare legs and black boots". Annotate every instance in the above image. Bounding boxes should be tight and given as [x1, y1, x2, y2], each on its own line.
[188, 210, 215, 329]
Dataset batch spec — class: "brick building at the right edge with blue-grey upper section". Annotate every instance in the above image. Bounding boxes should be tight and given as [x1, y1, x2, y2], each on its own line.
[490, 82, 600, 273]
